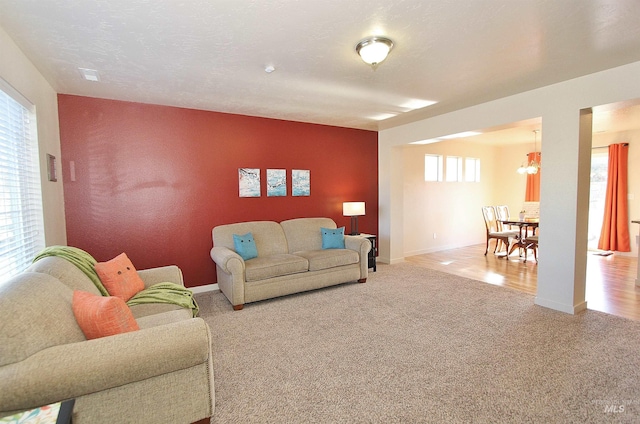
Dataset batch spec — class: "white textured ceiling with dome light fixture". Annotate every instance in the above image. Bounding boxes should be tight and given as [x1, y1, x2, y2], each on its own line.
[0, 0, 640, 138]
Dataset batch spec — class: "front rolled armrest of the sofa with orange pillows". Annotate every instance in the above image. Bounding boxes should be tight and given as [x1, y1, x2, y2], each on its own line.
[0, 318, 211, 411]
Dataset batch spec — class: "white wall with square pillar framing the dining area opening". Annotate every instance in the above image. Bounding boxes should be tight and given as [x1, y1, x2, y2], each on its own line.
[378, 62, 640, 313]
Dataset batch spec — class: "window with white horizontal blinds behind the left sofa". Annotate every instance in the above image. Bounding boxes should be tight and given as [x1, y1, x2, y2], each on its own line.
[0, 80, 45, 284]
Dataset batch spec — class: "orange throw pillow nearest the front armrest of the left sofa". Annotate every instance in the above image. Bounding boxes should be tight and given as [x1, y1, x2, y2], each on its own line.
[71, 290, 140, 340]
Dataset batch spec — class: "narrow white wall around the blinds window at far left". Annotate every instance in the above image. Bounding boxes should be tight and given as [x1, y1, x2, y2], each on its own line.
[0, 27, 67, 246]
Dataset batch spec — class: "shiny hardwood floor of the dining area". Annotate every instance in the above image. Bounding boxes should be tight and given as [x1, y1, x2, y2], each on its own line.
[406, 243, 640, 320]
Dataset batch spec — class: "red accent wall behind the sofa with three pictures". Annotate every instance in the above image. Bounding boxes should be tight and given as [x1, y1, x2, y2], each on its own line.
[58, 94, 378, 287]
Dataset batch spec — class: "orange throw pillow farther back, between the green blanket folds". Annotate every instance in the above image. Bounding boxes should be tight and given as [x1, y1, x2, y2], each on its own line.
[95, 253, 144, 302]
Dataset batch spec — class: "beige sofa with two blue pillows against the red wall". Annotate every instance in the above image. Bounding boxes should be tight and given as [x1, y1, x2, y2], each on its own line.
[211, 218, 371, 310]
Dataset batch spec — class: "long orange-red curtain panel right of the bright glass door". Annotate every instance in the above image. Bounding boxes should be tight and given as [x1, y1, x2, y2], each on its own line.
[598, 143, 631, 252]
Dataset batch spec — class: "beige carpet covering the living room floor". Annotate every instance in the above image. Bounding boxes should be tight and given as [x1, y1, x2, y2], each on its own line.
[197, 263, 640, 423]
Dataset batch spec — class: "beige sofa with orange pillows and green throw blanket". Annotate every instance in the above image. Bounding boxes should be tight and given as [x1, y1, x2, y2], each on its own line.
[0, 257, 215, 424]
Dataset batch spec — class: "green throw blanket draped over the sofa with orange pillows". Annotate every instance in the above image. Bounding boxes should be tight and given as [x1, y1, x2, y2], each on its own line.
[33, 246, 198, 317]
